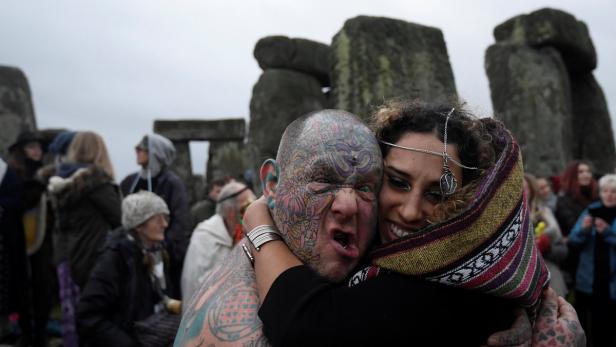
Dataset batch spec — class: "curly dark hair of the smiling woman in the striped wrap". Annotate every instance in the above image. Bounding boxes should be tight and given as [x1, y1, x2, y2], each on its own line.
[370, 100, 501, 222]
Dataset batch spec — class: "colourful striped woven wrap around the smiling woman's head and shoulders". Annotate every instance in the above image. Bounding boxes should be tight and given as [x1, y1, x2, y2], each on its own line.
[371, 120, 549, 307]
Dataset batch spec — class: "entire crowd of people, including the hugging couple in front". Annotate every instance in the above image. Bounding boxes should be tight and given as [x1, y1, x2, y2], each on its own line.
[0, 101, 616, 347]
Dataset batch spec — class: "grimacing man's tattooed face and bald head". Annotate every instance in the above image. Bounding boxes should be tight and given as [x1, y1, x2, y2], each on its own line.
[273, 115, 382, 281]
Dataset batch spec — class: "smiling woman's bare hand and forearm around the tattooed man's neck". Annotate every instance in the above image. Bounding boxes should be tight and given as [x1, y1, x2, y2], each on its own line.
[243, 197, 302, 303]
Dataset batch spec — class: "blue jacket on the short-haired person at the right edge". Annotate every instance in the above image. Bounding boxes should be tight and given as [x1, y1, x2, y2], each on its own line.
[569, 201, 616, 300]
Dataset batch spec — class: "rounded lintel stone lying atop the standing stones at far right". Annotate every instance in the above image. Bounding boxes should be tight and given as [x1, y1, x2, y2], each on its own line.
[494, 8, 597, 71]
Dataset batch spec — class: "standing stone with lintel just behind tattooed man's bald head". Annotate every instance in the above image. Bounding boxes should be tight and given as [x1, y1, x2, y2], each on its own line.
[246, 36, 330, 190]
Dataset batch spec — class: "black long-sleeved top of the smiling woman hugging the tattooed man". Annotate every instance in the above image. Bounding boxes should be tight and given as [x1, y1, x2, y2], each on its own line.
[259, 265, 513, 346]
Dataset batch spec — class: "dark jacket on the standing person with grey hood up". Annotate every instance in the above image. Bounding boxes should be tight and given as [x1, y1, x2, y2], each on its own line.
[120, 168, 190, 299]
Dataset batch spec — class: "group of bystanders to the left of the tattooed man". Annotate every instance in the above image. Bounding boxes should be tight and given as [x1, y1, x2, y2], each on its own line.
[0, 131, 254, 346]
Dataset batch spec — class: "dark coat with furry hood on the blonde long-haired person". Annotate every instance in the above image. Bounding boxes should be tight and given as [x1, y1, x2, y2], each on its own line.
[48, 164, 121, 288]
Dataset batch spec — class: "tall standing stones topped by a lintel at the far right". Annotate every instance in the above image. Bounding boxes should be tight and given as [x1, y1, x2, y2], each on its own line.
[485, 9, 616, 175]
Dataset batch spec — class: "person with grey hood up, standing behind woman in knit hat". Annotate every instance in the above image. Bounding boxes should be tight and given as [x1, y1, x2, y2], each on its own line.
[120, 134, 190, 299]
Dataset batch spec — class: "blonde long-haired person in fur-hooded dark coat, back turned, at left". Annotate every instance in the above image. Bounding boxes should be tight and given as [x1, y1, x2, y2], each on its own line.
[48, 131, 121, 347]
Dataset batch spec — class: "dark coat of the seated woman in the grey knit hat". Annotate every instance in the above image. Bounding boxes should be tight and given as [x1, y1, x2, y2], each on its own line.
[77, 228, 173, 347]
